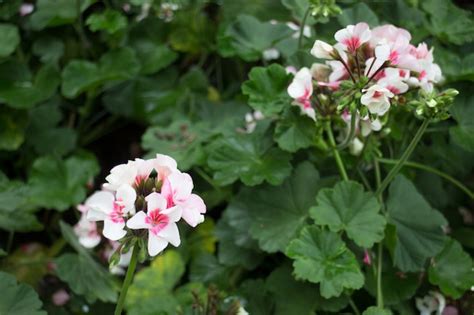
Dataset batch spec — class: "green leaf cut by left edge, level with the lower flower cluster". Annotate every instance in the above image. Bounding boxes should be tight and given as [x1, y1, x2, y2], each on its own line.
[0, 177, 43, 232]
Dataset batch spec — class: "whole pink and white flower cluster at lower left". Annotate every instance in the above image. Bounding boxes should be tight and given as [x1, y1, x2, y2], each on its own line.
[75, 154, 206, 256]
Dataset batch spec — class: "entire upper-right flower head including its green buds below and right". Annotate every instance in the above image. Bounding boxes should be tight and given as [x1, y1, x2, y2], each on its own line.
[288, 23, 456, 153]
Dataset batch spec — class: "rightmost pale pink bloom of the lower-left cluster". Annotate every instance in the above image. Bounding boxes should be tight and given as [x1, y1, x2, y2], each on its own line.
[161, 171, 206, 227]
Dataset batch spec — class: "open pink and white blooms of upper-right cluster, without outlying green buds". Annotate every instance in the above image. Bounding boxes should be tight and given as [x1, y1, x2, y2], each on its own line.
[288, 23, 442, 119]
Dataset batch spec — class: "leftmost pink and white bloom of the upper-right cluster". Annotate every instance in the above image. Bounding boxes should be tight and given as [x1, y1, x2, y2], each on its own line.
[288, 67, 316, 120]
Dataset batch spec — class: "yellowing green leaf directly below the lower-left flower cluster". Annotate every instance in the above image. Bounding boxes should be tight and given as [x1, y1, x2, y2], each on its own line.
[125, 249, 185, 315]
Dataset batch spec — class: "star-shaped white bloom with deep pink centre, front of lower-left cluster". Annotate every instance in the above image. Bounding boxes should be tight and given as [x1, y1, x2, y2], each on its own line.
[127, 192, 182, 256]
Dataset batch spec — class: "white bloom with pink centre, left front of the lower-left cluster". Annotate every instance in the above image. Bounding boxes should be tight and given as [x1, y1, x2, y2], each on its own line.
[86, 185, 137, 241]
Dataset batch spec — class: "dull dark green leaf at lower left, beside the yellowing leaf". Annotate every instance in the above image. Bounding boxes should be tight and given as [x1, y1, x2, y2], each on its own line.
[54, 253, 117, 303]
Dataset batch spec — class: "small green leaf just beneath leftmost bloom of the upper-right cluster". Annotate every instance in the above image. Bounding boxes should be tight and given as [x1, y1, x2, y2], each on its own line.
[274, 106, 318, 152]
